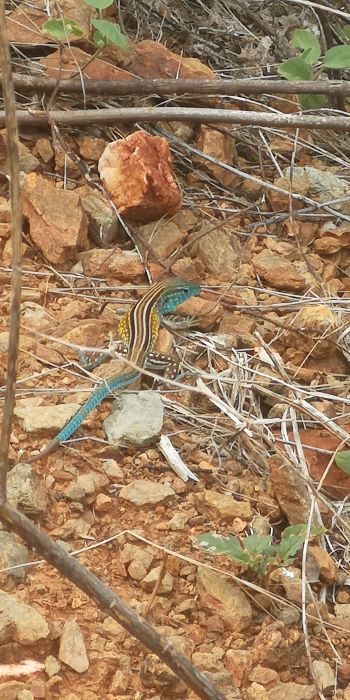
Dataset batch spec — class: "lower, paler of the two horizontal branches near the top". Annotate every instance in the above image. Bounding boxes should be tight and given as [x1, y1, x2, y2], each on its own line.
[0, 107, 350, 132]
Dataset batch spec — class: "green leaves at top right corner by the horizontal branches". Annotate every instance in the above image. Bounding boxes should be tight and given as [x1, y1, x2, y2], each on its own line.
[277, 25, 350, 109]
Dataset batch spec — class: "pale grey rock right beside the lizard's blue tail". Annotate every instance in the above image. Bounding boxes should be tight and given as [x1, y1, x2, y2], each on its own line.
[103, 390, 164, 447]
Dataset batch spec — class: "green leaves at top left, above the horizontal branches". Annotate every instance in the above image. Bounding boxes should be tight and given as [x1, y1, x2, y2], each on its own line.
[42, 0, 128, 49]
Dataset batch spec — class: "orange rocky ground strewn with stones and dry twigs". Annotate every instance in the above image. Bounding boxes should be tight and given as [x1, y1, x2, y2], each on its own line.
[0, 1, 350, 700]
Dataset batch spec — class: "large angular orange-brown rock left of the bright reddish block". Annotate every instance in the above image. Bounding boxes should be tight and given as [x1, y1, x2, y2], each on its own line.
[22, 173, 88, 263]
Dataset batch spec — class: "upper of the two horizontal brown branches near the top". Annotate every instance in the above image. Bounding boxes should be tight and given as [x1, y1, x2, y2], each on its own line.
[2, 73, 350, 96]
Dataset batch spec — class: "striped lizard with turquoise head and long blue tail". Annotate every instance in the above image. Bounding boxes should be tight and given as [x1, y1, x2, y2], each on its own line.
[25, 277, 200, 464]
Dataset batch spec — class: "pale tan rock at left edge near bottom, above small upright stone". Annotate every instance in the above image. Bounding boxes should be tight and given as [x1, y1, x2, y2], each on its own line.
[0, 590, 50, 644]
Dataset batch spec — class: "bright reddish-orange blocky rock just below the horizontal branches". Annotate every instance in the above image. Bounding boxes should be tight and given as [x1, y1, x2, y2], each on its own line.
[98, 131, 181, 223]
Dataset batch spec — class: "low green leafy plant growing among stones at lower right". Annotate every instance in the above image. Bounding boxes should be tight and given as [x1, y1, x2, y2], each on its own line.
[197, 525, 325, 574]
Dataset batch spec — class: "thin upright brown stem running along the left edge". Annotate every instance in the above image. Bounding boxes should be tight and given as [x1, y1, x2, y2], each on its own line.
[0, 0, 22, 503]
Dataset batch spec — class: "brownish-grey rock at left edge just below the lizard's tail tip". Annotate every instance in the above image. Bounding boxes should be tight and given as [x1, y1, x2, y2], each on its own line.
[7, 463, 48, 518]
